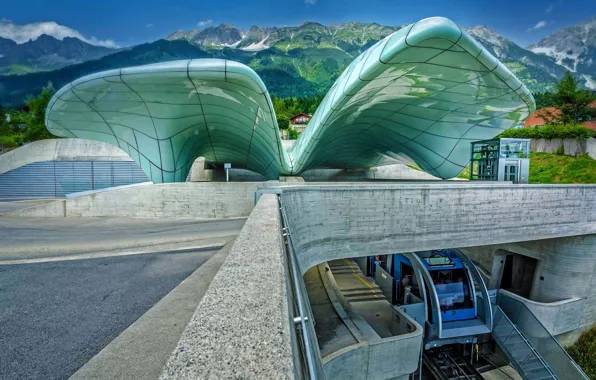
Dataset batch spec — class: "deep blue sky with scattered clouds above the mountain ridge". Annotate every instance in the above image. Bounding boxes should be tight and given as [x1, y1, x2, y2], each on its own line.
[0, 0, 596, 47]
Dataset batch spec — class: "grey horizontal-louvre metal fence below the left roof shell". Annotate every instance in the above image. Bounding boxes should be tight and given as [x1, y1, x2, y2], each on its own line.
[0, 161, 149, 199]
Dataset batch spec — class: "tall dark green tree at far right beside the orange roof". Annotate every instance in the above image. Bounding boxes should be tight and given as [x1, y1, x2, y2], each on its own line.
[553, 71, 596, 124]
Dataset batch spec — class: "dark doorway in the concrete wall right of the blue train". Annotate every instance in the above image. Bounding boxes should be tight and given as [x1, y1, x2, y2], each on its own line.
[500, 252, 538, 299]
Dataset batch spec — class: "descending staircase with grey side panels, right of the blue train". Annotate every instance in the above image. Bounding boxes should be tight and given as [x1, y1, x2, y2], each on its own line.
[492, 291, 589, 380]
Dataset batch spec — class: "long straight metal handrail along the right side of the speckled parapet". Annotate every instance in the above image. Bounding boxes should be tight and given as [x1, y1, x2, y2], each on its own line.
[278, 196, 325, 380]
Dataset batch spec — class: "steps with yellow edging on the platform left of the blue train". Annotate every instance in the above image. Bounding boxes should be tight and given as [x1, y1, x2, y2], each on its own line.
[328, 259, 386, 302]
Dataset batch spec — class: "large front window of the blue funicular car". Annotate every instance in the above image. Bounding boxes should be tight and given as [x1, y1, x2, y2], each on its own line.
[430, 269, 474, 312]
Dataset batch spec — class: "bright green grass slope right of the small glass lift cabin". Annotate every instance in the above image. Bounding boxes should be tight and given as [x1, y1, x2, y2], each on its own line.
[530, 152, 596, 183]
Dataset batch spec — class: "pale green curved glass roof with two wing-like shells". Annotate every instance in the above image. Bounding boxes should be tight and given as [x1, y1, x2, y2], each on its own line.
[46, 17, 535, 183]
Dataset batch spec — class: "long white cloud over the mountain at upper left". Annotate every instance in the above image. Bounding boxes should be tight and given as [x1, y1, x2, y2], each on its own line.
[0, 19, 118, 48]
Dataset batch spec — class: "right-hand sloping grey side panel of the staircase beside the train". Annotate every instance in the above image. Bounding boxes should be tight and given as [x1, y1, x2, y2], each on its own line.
[497, 292, 589, 380]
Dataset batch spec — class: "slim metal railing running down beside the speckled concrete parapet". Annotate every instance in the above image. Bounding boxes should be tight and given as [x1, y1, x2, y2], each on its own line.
[278, 196, 325, 380]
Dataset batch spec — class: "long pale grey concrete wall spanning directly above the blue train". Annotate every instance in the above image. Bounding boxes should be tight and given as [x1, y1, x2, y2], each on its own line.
[282, 184, 596, 271]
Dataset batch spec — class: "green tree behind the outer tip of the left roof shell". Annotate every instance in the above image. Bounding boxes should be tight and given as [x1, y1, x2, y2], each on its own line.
[11, 83, 55, 141]
